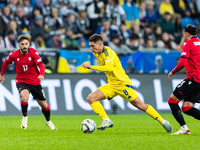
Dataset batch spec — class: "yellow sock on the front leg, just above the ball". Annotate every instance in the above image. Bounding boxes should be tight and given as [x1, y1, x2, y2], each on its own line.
[90, 101, 108, 120]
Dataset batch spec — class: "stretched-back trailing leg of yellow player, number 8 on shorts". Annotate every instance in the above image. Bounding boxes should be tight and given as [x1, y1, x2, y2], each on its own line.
[118, 85, 172, 132]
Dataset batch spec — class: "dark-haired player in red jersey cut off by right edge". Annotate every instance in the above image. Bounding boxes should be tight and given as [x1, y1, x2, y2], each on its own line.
[168, 25, 200, 134]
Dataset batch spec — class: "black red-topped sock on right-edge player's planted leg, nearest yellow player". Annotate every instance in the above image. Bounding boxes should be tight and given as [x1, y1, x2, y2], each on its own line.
[168, 97, 186, 126]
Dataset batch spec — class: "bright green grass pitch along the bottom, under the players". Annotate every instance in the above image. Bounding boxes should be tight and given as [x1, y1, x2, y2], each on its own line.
[0, 114, 200, 150]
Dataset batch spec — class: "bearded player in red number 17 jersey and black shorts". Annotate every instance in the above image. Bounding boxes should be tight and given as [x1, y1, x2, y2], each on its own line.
[0, 35, 56, 130]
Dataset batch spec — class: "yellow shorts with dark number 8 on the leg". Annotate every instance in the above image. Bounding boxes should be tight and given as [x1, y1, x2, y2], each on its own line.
[98, 84, 138, 102]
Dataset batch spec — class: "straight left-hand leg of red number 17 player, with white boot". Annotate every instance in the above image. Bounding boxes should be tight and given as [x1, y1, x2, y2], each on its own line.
[17, 83, 29, 129]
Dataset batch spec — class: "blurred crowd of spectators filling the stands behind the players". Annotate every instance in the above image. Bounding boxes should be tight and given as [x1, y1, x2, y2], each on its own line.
[0, 0, 200, 54]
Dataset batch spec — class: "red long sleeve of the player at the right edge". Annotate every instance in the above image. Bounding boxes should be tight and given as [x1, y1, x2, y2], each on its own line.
[172, 42, 191, 73]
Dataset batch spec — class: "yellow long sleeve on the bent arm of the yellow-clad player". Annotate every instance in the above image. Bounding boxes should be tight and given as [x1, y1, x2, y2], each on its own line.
[91, 51, 114, 72]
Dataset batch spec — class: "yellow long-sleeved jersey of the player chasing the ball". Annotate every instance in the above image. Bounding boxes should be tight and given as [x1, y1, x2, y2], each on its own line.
[92, 46, 132, 86]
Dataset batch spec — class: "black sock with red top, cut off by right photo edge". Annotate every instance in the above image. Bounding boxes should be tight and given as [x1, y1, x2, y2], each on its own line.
[182, 106, 200, 120]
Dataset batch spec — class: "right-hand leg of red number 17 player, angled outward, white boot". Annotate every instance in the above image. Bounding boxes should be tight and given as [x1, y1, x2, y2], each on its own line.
[30, 85, 56, 130]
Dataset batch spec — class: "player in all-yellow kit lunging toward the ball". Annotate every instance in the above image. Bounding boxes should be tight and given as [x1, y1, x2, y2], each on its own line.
[82, 34, 172, 132]
